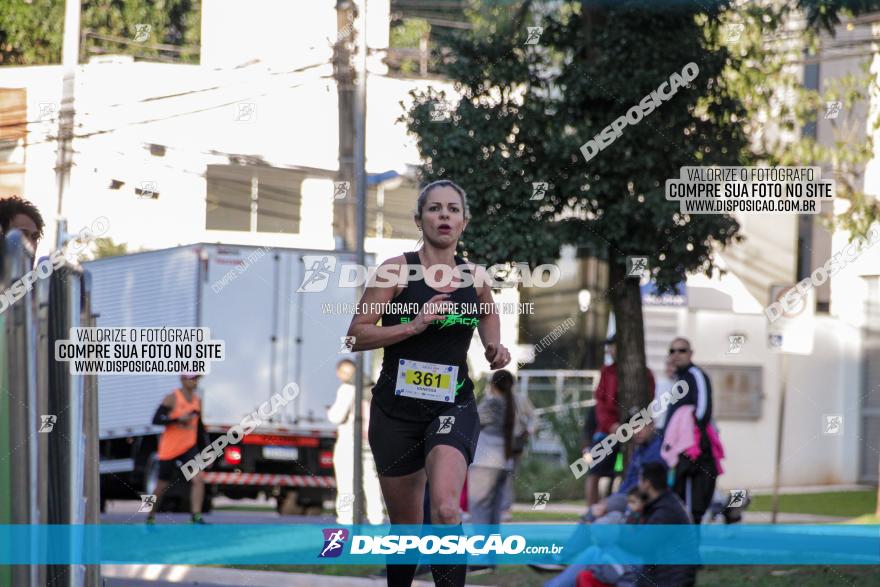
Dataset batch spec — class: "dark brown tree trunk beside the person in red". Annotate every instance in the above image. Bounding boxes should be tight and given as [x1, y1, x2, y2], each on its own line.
[608, 254, 650, 423]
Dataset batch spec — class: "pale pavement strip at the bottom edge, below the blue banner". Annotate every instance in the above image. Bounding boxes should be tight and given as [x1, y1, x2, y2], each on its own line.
[101, 565, 496, 587]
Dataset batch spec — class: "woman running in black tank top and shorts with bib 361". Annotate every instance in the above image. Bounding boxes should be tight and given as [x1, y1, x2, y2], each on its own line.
[348, 180, 510, 587]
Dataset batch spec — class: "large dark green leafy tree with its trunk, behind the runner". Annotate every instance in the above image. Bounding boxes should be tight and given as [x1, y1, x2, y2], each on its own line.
[406, 0, 750, 422]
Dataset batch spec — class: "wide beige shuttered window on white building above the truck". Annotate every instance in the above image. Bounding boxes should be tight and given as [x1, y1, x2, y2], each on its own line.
[205, 165, 304, 234]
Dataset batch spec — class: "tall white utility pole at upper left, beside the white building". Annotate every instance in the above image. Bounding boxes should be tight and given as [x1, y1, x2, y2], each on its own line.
[55, 0, 82, 248]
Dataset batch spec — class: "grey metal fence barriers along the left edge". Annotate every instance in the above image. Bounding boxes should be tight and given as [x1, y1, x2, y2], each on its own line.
[0, 231, 100, 587]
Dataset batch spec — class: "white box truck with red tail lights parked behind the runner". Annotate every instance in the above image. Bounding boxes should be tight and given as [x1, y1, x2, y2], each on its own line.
[85, 244, 371, 513]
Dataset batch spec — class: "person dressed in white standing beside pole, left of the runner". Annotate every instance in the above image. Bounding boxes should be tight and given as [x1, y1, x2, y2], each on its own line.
[327, 359, 384, 524]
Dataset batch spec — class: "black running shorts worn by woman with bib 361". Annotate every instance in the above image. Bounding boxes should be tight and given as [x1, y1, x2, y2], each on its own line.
[369, 401, 480, 477]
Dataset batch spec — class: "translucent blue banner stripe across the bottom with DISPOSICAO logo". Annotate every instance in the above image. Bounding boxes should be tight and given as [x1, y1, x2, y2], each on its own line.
[0, 524, 880, 565]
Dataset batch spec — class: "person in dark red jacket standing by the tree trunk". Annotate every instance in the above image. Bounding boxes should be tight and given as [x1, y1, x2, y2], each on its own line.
[584, 334, 654, 508]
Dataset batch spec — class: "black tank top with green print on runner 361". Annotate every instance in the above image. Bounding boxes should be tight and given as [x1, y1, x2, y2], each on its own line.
[373, 251, 479, 422]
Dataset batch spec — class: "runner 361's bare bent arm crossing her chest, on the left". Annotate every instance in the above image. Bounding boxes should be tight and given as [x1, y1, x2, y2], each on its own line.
[348, 255, 449, 351]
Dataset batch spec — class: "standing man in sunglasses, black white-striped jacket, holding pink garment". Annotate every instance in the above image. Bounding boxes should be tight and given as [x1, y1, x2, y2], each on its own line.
[663, 337, 718, 524]
